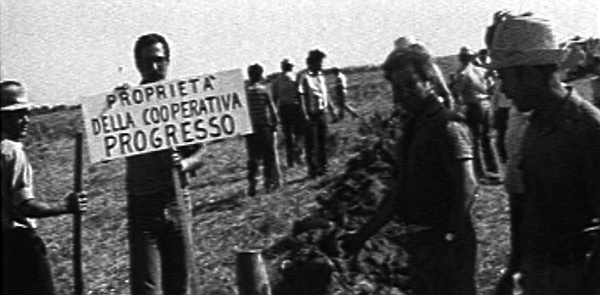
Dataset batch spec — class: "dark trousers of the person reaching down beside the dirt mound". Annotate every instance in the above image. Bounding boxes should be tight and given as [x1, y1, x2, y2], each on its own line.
[404, 221, 477, 295]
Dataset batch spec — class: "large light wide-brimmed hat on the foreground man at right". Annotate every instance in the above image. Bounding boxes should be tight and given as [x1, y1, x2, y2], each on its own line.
[484, 14, 565, 69]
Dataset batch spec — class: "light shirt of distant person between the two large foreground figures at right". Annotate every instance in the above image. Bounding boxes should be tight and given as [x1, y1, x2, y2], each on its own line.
[454, 64, 490, 104]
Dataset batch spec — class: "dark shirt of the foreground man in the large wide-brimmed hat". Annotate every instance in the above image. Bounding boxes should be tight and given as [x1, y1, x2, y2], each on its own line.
[521, 90, 600, 253]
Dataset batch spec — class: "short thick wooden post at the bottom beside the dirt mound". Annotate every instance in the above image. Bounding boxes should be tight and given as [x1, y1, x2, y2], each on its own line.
[236, 250, 271, 295]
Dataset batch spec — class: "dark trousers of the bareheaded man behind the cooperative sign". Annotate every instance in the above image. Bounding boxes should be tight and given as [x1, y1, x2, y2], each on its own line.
[127, 188, 193, 295]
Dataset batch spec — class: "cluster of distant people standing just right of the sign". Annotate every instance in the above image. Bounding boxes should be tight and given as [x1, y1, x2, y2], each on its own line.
[245, 49, 358, 196]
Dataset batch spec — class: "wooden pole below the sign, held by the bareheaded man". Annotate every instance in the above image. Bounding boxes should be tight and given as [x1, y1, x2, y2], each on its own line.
[173, 150, 200, 295]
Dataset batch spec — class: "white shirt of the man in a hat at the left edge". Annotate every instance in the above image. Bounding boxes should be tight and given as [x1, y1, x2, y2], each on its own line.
[1, 134, 36, 231]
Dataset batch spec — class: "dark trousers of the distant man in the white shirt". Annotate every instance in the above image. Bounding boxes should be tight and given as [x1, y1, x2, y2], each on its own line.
[304, 112, 327, 177]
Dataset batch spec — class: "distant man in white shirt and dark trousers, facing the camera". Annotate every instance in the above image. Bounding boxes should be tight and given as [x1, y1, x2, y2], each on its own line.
[298, 49, 337, 178]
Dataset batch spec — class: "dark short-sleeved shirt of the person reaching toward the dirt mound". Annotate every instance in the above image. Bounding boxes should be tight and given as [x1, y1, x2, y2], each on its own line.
[398, 106, 473, 226]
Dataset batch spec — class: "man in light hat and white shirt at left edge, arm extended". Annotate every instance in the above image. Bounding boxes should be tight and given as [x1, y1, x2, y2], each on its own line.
[0, 81, 87, 295]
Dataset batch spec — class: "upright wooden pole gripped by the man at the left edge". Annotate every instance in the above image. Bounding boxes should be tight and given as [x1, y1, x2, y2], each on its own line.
[73, 133, 84, 295]
